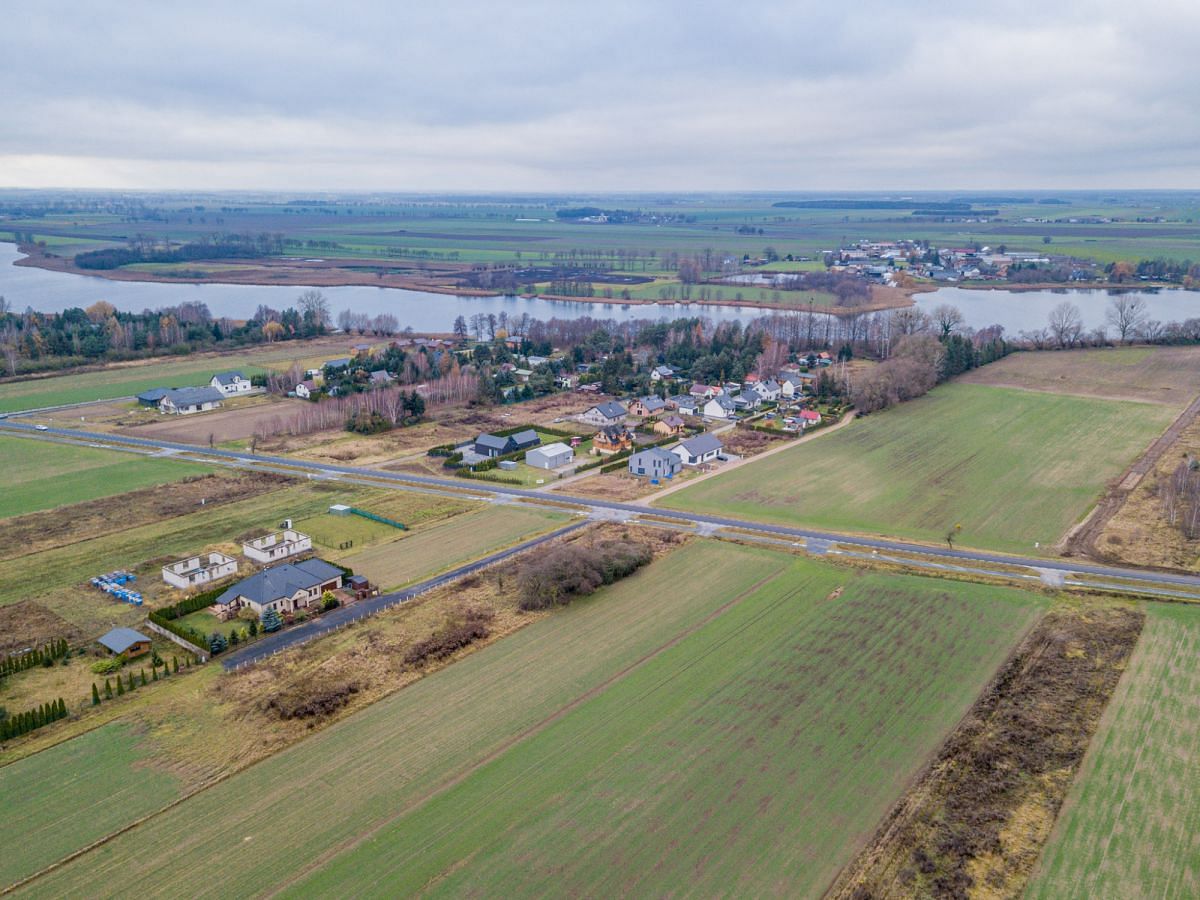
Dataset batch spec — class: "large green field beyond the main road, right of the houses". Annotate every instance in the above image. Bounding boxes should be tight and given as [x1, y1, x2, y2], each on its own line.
[662, 384, 1175, 553]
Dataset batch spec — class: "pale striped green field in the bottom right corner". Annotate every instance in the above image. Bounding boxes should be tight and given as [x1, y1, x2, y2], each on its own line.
[1028, 604, 1200, 899]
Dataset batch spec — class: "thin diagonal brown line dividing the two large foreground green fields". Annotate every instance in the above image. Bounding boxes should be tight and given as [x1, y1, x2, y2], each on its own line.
[265, 564, 790, 896]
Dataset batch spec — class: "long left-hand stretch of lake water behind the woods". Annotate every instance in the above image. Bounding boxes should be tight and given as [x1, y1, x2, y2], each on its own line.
[0, 242, 762, 331]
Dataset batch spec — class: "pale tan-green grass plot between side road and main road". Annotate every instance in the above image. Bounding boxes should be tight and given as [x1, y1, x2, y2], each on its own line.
[332, 506, 568, 590]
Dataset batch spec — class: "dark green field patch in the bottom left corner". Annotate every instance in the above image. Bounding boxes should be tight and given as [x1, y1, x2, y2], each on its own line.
[0, 725, 182, 887]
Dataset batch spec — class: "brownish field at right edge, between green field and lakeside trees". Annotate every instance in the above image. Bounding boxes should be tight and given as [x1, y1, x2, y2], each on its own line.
[956, 347, 1200, 410]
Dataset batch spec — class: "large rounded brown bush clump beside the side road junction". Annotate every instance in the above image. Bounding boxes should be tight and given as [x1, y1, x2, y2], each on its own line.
[517, 540, 653, 611]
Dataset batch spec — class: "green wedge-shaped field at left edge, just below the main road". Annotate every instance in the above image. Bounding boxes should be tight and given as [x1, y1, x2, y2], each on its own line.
[0, 436, 211, 518]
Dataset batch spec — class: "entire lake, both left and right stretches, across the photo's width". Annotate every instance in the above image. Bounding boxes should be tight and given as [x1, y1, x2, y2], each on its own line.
[0, 242, 1200, 335]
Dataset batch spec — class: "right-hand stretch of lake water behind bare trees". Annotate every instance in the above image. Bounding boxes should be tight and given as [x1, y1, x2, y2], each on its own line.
[916, 287, 1200, 337]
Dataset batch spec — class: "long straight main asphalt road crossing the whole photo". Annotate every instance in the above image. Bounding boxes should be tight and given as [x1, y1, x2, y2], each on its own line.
[0, 420, 1200, 600]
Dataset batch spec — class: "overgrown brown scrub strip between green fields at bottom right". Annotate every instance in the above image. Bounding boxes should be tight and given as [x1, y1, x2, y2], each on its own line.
[830, 606, 1145, 900]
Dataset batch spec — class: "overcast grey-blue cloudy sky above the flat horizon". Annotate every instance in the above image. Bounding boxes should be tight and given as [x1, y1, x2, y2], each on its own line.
[0, 0, 1200, 191]
